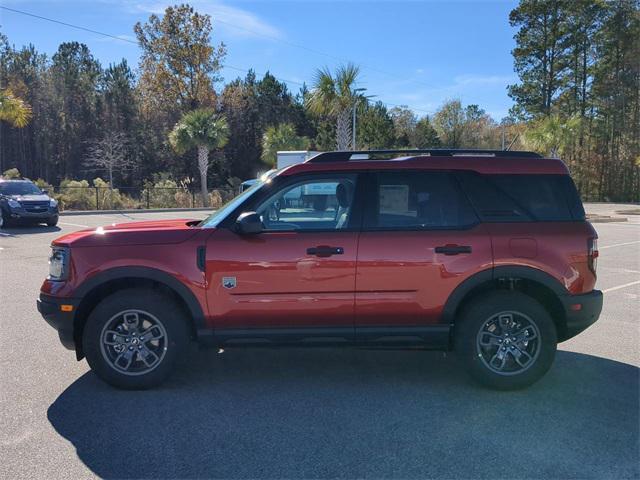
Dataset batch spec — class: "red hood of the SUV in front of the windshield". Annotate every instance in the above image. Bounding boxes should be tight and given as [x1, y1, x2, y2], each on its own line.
[53, 219, 201, 247]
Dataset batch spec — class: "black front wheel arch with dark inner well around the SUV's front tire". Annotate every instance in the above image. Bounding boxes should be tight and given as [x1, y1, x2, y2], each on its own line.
[73, 267, 206, 359]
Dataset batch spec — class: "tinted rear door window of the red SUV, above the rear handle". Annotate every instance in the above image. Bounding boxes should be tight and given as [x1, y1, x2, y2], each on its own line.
[365, 172, 478, 230]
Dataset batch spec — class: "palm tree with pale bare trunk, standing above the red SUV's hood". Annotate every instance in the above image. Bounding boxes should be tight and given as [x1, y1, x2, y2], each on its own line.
[169, 108, 229, 207]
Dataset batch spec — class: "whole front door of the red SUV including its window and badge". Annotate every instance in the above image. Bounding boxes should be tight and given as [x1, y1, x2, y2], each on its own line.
[206, 173, 359, 339]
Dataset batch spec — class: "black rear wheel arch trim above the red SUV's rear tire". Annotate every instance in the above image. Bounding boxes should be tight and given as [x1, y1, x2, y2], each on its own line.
[442, 266, 569, 339]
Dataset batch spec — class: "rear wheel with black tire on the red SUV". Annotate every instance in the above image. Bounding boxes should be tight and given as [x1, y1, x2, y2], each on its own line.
[454, 291, 557, 390]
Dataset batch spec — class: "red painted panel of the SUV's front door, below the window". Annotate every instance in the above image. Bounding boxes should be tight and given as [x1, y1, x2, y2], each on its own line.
[207, 229, 358, 328]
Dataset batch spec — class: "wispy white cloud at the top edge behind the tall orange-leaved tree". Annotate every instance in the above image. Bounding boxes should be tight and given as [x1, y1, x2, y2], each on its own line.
[125, 0, 284, 40]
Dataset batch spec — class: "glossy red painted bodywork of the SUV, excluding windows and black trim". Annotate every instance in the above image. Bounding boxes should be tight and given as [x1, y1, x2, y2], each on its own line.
[41, 157, 597, 334]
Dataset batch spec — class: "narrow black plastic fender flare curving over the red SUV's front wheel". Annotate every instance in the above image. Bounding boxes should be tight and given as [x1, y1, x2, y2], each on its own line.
[74, 267, 207, 331]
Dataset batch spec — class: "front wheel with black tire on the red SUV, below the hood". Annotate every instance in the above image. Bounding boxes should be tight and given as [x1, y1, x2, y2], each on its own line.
[82, 289, 189, 390]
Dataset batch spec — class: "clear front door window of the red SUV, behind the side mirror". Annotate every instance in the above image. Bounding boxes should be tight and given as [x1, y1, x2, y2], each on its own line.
[256, 174, 356, 231]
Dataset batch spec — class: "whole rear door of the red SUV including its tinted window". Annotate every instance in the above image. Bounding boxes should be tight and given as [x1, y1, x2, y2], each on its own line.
[356, 170, 492, 340]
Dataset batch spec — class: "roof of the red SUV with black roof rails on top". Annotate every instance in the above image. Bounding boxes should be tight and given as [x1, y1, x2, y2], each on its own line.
[281, 150, 569, 176]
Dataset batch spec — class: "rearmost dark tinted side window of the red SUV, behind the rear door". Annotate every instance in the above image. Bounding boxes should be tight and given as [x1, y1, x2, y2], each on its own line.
[460, 172, 584, 222]
